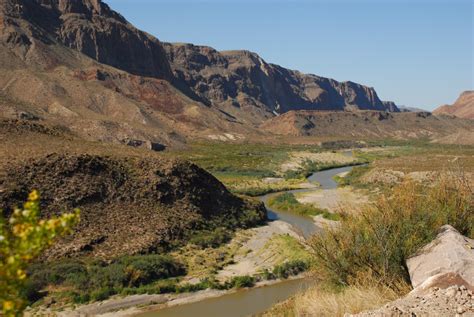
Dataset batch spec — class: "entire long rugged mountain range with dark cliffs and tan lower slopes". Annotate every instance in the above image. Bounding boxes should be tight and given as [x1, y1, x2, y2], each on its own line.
[0, 0, 398, 148]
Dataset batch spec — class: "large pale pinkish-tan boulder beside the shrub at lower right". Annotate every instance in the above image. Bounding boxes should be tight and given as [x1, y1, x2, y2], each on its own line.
[407, 225, 474, 288]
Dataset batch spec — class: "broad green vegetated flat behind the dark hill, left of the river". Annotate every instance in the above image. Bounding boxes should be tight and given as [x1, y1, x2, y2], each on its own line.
[164, 142, 366, 196]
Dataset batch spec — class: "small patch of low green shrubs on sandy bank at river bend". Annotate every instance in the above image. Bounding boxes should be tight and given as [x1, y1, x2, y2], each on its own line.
[268, 193, 340, 221]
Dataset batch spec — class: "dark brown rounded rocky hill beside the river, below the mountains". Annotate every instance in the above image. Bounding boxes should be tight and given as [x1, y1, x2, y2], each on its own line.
[0, 121, 265, 259]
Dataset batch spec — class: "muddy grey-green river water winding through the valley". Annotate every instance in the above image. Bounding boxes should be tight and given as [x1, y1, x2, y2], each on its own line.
[138, 162, 353, 317]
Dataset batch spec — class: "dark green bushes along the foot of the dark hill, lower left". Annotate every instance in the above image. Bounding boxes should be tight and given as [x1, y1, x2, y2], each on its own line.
[29, 254, 186, 302]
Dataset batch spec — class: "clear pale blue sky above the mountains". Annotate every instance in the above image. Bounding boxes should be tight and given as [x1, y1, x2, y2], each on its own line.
[105, 0, 474, 110]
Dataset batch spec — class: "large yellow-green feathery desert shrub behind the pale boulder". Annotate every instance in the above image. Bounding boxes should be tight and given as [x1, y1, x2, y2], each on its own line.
[310, 176, 474, 291]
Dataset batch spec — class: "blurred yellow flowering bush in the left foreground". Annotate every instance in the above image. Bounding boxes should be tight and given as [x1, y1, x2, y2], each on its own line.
[0, 191, 79, 316]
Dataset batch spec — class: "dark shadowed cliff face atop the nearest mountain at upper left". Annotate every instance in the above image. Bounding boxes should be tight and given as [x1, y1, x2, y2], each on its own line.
[0, 0, 172, 80]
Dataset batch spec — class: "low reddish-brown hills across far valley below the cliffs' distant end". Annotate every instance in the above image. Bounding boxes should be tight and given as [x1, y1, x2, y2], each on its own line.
[261, 111, 474, 142]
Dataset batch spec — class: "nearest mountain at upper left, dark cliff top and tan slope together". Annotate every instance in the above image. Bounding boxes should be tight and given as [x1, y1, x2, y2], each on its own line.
[0, 0, 260, 146]
